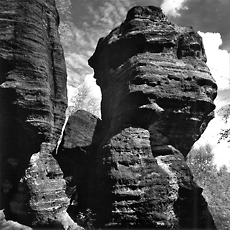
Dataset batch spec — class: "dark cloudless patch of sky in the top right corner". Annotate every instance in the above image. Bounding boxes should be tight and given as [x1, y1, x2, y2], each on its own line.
[169, 0, 230, 52]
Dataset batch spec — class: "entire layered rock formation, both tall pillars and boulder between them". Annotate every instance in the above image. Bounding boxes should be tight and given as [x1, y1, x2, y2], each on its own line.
[0, 0, 217, 230]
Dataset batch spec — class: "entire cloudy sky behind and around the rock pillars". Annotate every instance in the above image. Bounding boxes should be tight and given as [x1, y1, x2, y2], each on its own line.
[57, 0, 230, 168]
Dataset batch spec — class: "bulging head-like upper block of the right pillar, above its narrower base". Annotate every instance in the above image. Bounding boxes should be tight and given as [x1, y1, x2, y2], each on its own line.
[89, 6, 217, 155]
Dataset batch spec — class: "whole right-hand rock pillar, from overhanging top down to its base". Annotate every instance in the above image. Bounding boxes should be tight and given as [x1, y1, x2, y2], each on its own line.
[89, 6, 217, 229]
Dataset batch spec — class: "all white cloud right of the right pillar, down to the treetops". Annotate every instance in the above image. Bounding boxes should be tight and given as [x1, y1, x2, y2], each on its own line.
[187, 32, 230, 168]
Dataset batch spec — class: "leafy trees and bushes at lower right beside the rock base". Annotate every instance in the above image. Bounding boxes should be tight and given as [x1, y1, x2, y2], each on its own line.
[187, 145, 230, 230]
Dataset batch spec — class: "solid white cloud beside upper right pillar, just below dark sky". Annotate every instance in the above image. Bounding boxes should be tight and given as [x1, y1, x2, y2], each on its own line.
[198, 32, 230, 90]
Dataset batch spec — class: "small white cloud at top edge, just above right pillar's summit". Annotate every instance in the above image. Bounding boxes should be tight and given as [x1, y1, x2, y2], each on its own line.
[161, 0, 188, 17]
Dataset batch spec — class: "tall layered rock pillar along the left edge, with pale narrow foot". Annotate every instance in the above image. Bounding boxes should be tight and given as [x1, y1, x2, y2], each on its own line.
[0, 0, 80, 229]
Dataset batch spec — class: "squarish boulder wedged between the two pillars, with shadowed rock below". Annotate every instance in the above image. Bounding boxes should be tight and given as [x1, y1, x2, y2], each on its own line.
[56, 110, 103, 218]
